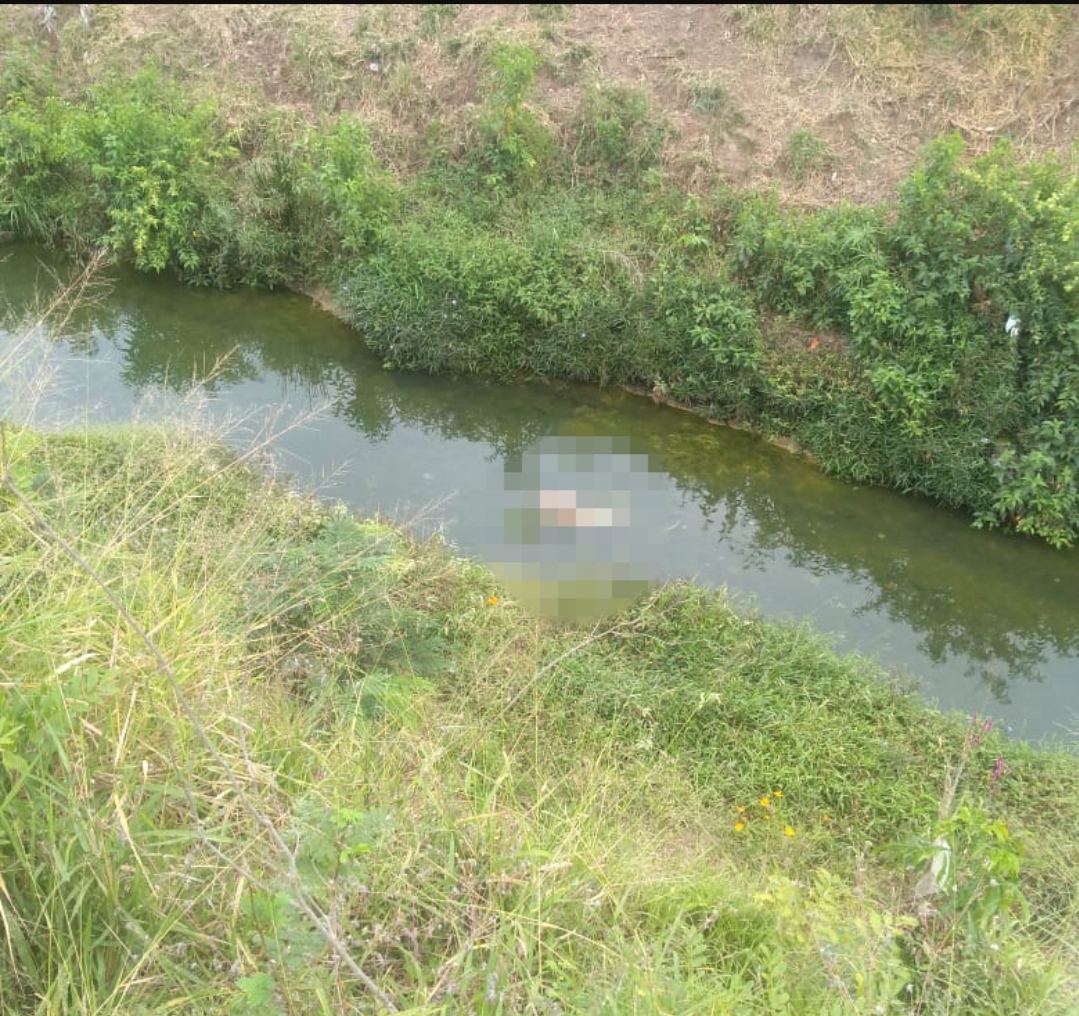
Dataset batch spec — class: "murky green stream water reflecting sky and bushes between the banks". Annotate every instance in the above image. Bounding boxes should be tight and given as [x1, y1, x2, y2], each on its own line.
[6, 247, 1079, 737]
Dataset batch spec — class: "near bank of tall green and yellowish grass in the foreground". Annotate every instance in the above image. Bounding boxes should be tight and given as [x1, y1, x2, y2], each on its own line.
[0, 412, 1079, 1016]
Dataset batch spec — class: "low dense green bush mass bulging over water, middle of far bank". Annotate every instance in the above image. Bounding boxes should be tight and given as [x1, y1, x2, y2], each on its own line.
[340, 198, 761, 416]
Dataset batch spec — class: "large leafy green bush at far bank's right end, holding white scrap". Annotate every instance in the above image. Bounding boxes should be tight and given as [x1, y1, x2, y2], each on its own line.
[729, 138, 1079, 545]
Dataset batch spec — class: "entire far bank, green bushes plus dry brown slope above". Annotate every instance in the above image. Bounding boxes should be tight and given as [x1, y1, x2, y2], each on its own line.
[0, 4, 1079, 546]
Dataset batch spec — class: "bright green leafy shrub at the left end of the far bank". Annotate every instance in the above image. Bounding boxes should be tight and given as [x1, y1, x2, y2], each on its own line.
[0, 62, 234, 272]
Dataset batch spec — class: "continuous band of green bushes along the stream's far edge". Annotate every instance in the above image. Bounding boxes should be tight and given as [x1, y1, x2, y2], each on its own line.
[0, 44, 1079, 545]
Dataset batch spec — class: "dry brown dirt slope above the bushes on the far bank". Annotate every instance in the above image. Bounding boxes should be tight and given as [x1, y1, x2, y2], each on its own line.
[8, 4, 1079, 206]
